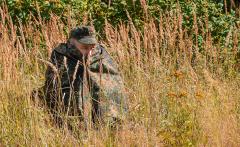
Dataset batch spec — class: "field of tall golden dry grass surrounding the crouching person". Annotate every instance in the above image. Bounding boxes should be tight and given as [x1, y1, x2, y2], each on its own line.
[0, 4, 240, 147]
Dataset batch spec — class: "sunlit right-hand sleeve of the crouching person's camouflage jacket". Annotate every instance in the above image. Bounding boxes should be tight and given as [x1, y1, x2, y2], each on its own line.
[89, 45, 127, 124]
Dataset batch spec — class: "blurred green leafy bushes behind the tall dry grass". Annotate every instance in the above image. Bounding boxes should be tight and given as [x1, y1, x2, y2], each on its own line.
[2, 0, 240, 58]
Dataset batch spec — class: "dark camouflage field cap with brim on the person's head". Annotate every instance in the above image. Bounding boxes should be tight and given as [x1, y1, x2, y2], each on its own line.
[70, 26, 97, 44]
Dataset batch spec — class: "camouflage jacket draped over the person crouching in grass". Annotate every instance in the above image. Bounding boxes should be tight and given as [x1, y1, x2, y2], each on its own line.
[44, 43, 127, 125]
